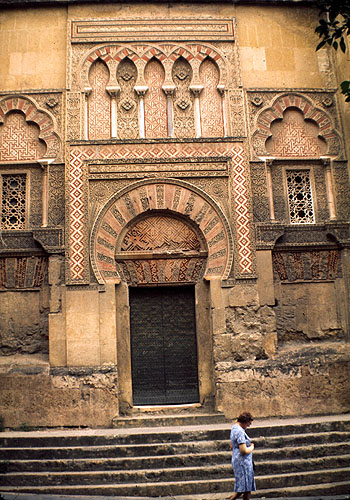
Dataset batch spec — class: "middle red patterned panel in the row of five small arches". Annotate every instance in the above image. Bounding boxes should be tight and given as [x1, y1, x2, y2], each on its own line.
[145, 59, 168, 139]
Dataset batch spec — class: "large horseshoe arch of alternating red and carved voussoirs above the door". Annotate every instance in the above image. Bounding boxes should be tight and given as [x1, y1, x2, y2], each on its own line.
[90, 179, 233, 283]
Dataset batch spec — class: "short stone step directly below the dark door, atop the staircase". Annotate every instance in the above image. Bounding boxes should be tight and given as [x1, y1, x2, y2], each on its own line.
[112, 413, 227, 429]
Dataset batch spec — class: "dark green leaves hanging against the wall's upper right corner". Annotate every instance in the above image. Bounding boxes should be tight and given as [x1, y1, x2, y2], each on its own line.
[315, 0, 350, 102]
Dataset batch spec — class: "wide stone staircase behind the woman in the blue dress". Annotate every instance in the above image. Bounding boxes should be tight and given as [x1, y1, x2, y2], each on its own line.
[0, 415, 350, 499]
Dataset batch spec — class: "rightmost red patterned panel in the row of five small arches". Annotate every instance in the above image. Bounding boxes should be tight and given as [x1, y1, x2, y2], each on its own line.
[199, 59, 224, 137]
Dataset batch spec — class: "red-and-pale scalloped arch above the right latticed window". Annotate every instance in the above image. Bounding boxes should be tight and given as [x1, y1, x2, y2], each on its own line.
[253, 93, 342, 156]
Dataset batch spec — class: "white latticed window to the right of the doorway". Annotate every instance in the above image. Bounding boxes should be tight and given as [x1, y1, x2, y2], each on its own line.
[286, 170, 315, 224]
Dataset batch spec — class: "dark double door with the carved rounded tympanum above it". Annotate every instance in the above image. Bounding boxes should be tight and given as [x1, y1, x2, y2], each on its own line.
[116, 211, 208, 406]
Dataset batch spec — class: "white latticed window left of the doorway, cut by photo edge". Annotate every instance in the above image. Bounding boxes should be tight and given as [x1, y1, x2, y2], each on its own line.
[1, 174, 26, 229]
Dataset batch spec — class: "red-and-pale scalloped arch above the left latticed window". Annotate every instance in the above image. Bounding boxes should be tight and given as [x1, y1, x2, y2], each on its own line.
[0, 95, 61, 159]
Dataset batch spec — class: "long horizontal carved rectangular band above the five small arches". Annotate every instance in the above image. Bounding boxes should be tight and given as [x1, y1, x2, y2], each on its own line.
[70, 18, 235, 43]
